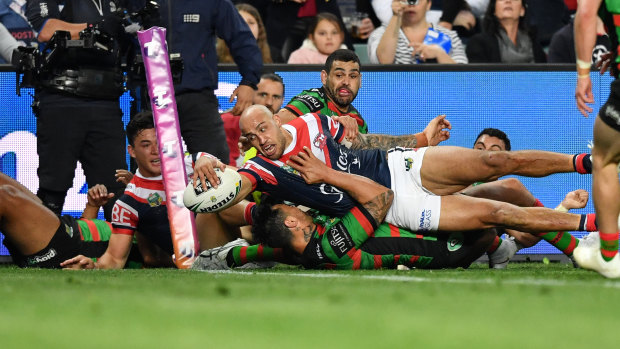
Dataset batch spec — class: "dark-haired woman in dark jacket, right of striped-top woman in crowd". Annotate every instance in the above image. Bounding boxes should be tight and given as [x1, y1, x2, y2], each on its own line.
[467, 0, 547, 63]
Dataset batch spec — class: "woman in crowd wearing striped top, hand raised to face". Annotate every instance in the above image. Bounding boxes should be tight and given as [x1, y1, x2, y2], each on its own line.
[368, 0, 467, 64]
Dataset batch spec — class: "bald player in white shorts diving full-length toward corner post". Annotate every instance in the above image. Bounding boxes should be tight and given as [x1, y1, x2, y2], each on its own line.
[214, 106, 596, 232]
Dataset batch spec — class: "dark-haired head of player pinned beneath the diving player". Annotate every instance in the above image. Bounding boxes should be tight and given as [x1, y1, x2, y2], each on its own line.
[252, 196, 314, 249]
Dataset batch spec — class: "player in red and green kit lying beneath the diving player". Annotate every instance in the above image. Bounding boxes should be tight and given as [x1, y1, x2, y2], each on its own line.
[192, 152, 494, 270]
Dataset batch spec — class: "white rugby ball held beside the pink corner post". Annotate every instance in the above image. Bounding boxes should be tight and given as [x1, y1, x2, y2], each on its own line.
[183, 168, 241, 213]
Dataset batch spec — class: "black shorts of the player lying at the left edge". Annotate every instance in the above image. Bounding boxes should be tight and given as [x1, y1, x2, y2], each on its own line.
[4, 216, 81, 268]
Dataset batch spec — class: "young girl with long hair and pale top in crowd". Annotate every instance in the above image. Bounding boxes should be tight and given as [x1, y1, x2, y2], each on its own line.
[288, 12, 347, 64]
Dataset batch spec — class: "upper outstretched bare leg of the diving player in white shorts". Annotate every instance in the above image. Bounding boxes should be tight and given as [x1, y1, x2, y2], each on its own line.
[420, 146, 575, 195]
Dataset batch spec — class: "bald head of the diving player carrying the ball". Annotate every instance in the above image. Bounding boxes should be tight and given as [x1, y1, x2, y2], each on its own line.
[239, 104, 290, 160]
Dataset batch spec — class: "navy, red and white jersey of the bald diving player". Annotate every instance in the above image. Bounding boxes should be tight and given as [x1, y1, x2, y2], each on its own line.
[239, 113, 390, 217]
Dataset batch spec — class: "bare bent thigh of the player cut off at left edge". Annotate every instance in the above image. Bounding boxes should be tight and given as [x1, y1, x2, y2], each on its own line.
[0, 174, 60, 255]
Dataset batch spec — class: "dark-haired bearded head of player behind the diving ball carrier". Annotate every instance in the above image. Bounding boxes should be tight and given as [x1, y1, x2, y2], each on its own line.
[321, 49, 362, 109]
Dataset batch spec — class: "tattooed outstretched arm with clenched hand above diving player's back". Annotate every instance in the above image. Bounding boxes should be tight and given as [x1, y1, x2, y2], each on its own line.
[350, 115, 452, 150]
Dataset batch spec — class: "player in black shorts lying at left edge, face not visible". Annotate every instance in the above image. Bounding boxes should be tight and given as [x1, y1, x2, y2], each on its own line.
[0, 173, 142, 268]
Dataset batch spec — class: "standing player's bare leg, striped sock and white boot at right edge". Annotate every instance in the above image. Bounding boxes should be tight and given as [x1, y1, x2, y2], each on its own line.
[575, 117, 620, 278]
